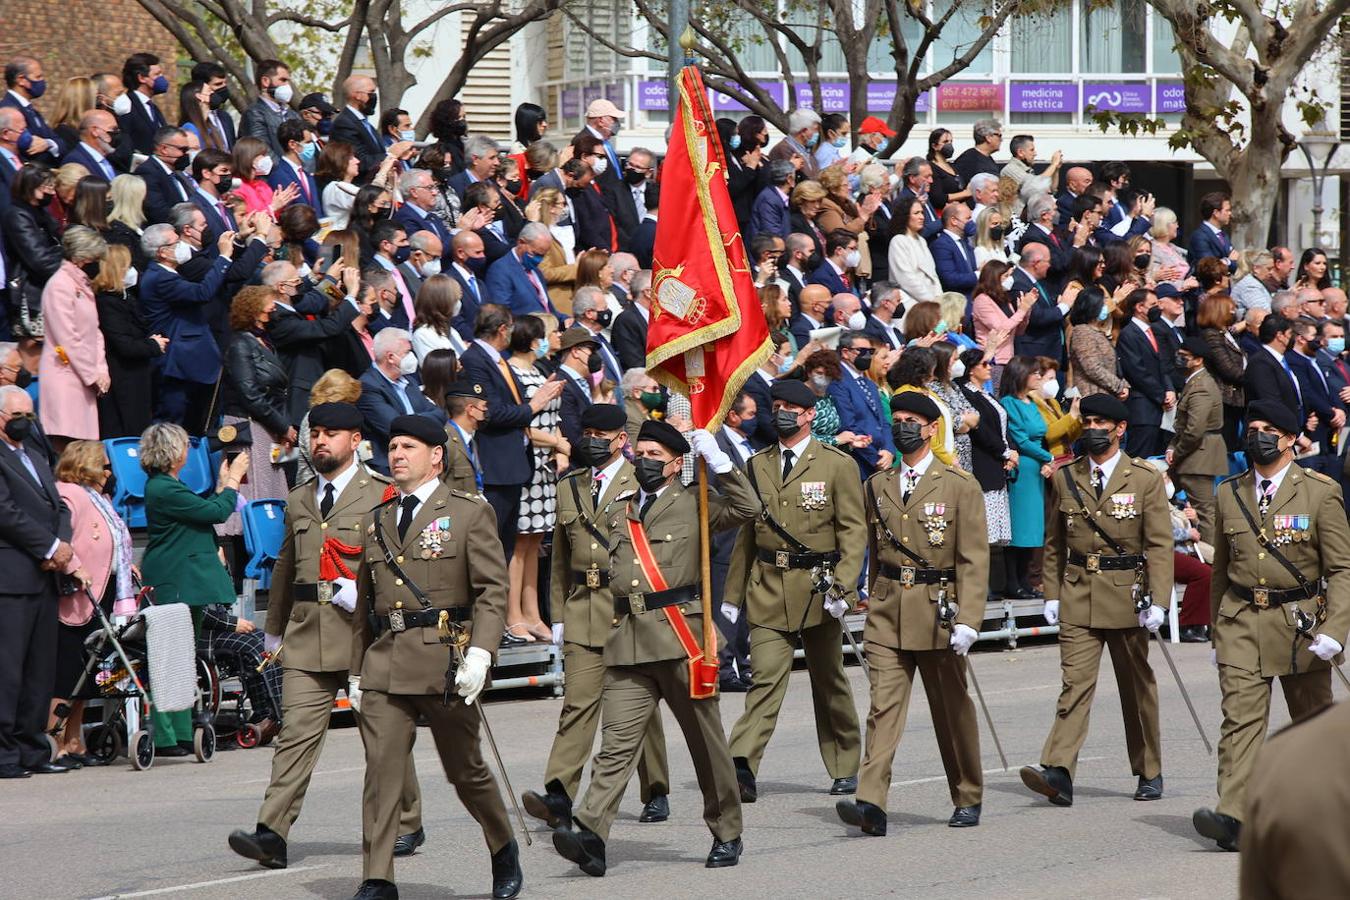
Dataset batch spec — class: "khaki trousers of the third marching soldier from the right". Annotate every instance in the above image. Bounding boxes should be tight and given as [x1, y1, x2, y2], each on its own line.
[857, 644, 984, 810]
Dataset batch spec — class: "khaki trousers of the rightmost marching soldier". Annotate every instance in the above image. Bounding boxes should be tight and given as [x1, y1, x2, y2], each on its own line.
[1215, 665, 1331, 820]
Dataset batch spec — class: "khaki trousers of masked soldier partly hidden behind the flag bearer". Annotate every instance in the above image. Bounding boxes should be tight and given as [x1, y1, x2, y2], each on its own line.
[544, 642, 671, 803]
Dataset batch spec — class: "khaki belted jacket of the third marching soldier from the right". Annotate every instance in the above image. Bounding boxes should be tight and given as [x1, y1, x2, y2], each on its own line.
[863, 459, 990, 650]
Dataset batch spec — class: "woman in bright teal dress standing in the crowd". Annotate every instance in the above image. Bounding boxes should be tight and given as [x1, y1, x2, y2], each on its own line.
[999, 356, 1054, 599]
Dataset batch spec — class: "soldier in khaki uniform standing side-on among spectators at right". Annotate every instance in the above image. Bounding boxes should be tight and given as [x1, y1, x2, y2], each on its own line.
[1166, 335, 1229, 544]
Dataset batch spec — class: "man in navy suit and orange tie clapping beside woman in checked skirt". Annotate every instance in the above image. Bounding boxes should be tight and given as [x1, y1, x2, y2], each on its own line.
[459, 304, 564, 556]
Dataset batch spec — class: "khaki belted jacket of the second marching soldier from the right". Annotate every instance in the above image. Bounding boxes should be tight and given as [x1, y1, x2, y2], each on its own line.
[1045, 451, 1175, 629]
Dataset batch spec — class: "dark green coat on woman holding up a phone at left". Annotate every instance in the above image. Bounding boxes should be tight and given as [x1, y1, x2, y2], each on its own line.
[140, 472, 236, 606]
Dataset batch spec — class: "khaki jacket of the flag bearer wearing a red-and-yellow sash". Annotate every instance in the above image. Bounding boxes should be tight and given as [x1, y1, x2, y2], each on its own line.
[602, 468, 760, 665]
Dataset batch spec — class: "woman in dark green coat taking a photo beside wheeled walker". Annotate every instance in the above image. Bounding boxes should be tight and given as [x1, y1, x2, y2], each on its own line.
[140, 422, 248, 756]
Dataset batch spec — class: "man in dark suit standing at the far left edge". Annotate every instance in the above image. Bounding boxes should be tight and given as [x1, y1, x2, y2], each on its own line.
[0, 385, 89, 779]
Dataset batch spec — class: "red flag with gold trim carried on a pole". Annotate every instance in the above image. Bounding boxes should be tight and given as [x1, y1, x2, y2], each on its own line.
[647, 66, 774, 429]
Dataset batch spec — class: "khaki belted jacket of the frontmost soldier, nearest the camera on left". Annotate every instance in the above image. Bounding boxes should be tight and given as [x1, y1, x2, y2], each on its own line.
[351, 484, 508, 694]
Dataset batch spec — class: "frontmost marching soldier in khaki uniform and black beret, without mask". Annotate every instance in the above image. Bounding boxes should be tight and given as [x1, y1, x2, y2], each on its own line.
[347, 416, 524, 900]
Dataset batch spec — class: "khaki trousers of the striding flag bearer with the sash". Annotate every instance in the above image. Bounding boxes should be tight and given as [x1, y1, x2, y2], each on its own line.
[574, 658, 741, 841]
